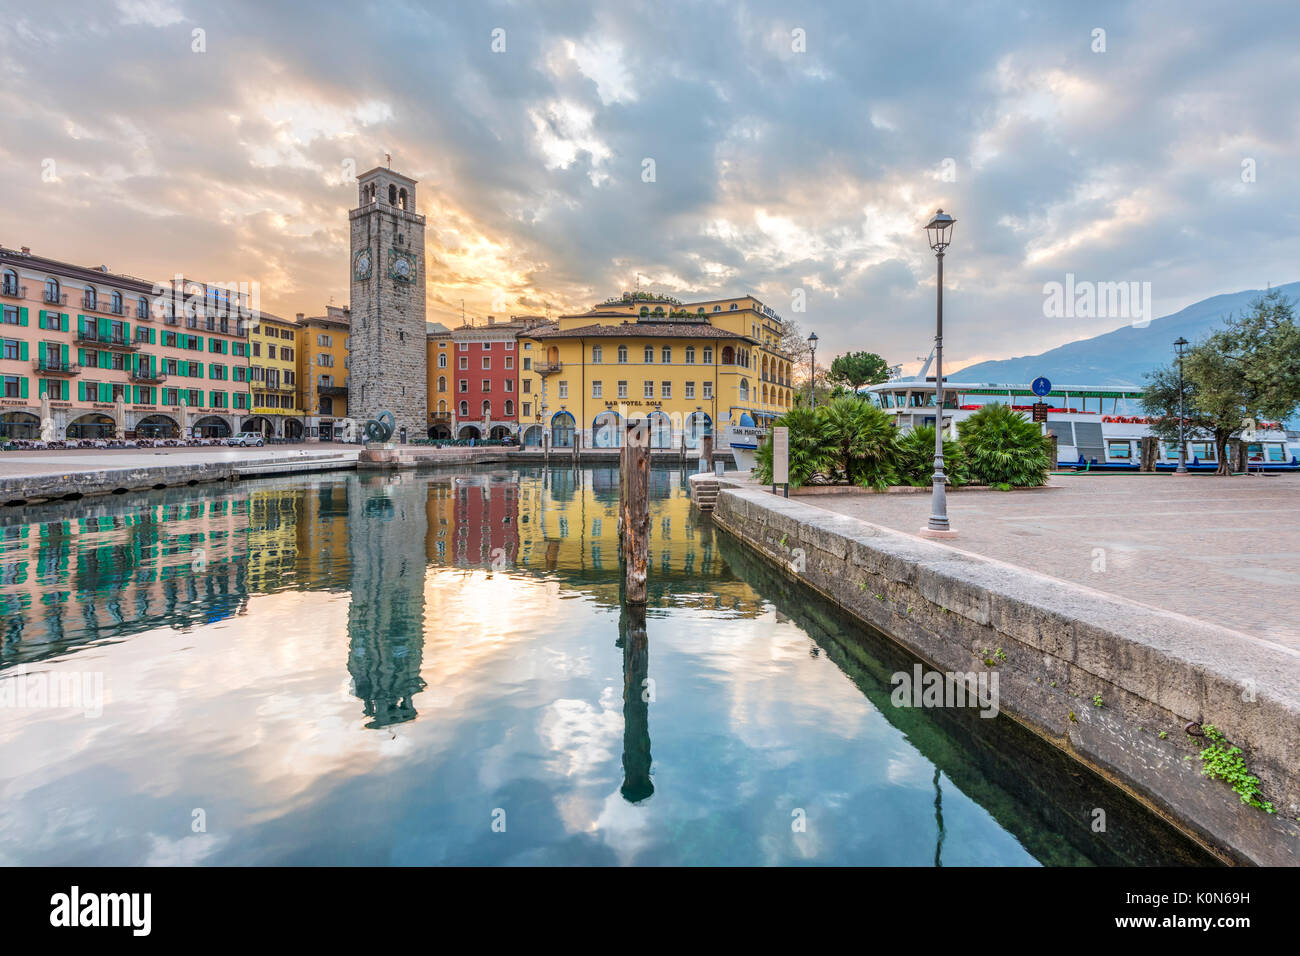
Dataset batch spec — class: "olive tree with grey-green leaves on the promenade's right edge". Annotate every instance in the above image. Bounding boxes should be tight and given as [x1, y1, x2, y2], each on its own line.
[1143, 289, 1300, 475]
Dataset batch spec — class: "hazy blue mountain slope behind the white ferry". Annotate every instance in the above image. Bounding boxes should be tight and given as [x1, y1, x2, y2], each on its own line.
[944, 282, 1300, 386]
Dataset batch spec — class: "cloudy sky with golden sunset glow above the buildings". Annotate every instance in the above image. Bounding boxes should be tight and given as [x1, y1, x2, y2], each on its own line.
[0, 0, 1300, 368]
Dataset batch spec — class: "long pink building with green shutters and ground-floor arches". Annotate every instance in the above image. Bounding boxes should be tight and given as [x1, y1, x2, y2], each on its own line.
[0, 247, 254, 440]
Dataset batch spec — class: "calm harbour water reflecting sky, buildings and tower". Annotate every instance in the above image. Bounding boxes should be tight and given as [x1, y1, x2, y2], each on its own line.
[0, 468, 1208, 866]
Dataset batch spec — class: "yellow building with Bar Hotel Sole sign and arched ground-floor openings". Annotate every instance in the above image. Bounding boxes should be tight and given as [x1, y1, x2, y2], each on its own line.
[519, 293, 793, 447]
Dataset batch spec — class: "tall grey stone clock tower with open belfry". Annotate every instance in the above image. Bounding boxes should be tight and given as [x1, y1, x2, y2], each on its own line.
[346, 166, 429, 441]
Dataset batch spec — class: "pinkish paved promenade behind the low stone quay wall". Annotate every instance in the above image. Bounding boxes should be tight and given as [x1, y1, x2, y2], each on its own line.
[798, 475, 1300, 650]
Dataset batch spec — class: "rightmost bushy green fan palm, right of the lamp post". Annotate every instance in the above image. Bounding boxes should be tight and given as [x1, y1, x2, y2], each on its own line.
[956, 403, 1052, 490]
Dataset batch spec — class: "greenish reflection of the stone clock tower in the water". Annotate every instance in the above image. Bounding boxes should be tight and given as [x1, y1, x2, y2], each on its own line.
[347, 472, 426, 728]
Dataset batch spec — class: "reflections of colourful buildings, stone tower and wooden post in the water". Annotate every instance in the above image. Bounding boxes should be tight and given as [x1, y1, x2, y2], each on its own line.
[0, 467, 764, 749]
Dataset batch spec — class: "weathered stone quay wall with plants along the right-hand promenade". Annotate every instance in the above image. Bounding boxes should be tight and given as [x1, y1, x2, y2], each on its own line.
[712, 483, 1300, 866]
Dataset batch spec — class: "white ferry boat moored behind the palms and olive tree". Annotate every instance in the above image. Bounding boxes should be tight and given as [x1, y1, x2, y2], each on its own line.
[859, 376, 1300, 471]
